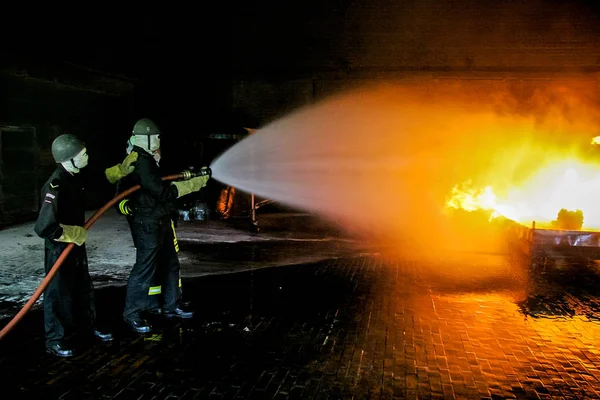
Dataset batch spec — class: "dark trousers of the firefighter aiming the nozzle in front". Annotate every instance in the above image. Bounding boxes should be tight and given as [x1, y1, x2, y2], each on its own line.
[123, 217, 180, 320]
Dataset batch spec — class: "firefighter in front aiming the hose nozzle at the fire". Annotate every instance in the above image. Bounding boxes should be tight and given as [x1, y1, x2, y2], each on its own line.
[123, 118, 209, 333]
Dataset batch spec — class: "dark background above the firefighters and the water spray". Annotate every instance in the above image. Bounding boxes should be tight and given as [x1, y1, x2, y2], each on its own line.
[0, 0, 600, 225]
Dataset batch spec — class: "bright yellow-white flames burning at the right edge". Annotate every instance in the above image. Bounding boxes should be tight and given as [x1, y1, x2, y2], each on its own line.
[446, 159, 600, 229]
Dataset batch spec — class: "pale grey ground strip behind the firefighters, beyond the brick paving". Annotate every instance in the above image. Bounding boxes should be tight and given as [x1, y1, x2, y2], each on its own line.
[0, 209, 349, 320]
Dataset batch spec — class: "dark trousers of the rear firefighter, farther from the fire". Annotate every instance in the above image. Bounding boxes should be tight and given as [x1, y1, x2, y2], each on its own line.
[43, 244, 96, 346]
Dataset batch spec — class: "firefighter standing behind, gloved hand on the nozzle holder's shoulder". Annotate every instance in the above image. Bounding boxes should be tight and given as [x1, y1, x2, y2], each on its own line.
[34, 134, 137, 357]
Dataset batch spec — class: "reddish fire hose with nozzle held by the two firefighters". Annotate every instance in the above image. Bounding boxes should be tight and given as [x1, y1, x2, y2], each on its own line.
[0, 168, 212, 340]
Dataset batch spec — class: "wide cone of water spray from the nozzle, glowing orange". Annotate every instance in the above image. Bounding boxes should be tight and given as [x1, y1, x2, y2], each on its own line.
[211, 80, 599, 255]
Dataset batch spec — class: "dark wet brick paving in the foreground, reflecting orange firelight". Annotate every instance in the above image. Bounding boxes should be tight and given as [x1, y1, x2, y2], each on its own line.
[0, 247, 600, 399]
